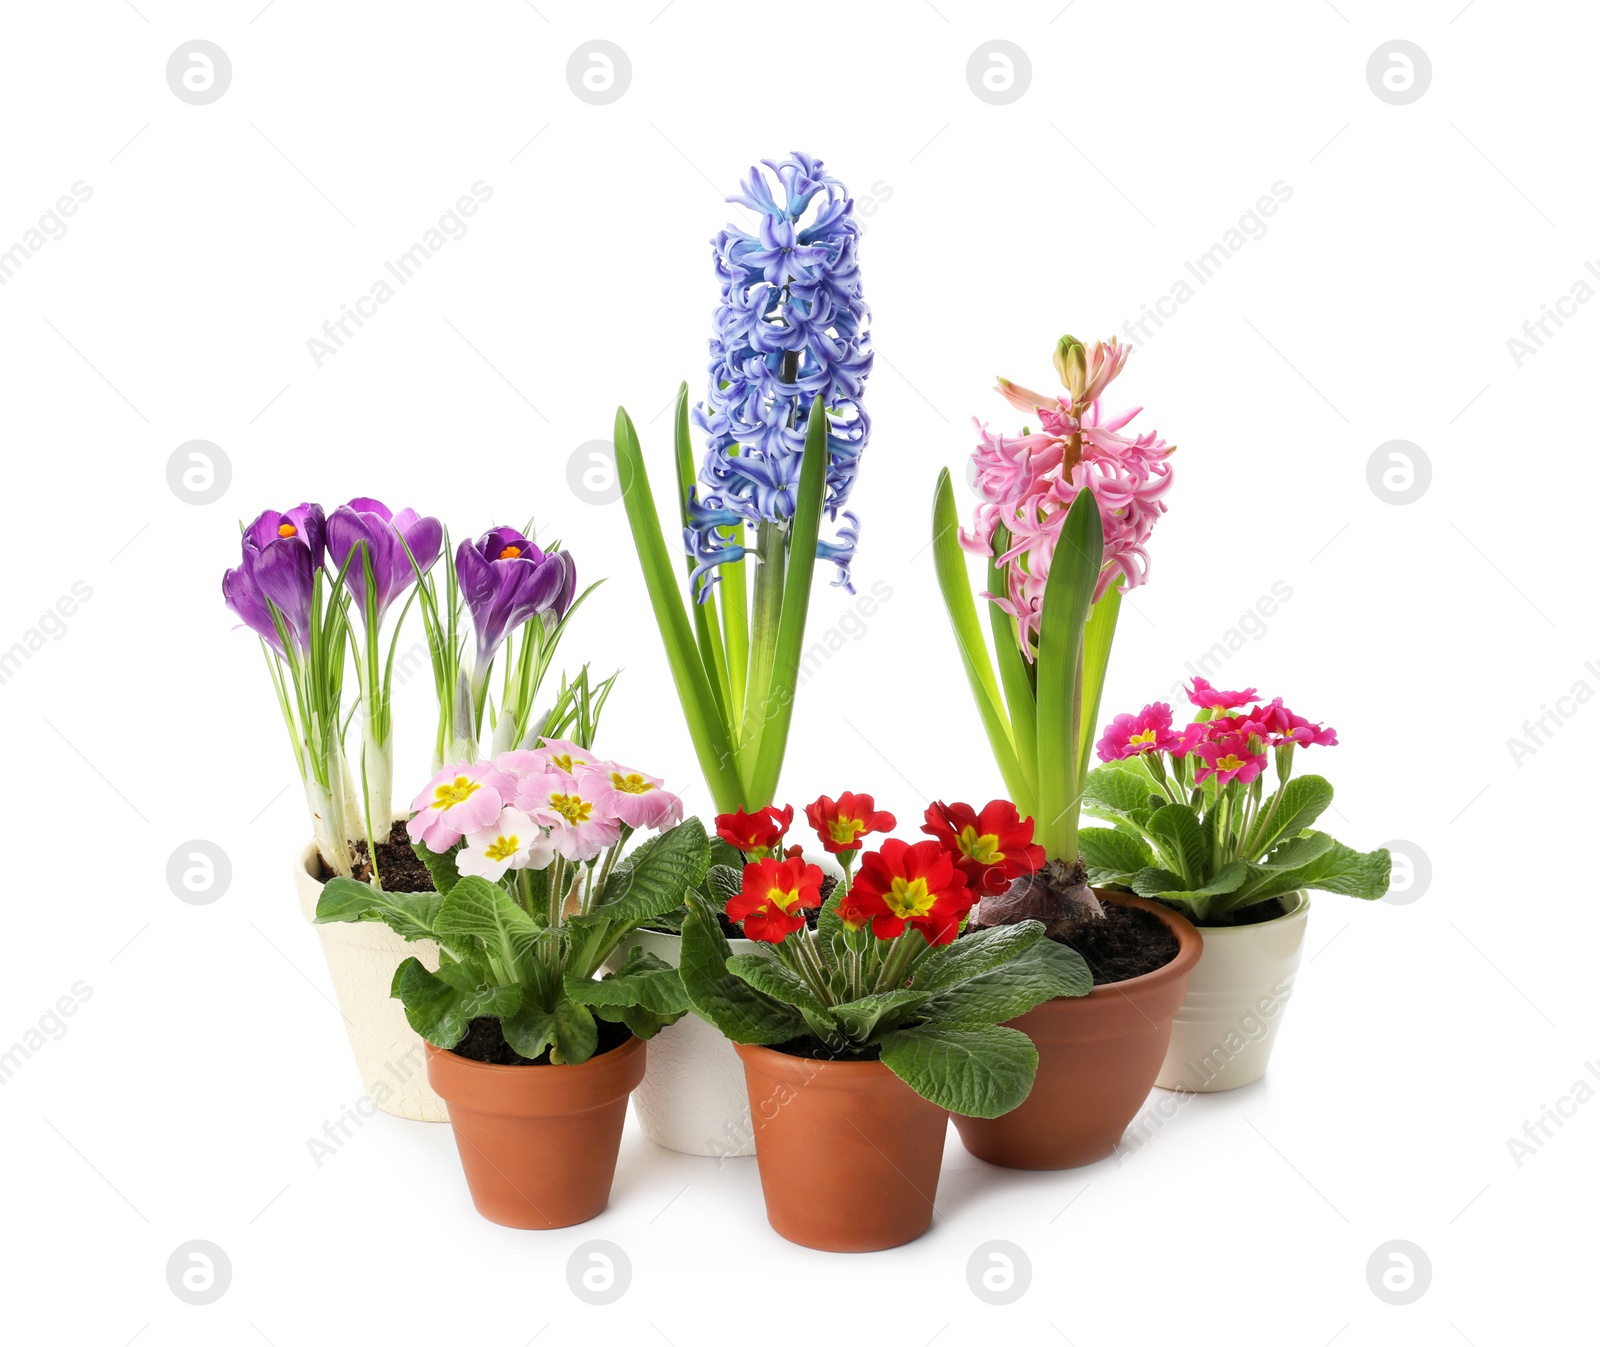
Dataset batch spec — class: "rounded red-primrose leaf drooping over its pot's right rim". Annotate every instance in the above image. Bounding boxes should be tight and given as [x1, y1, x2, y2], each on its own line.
[882, 1024, 1038, 1118]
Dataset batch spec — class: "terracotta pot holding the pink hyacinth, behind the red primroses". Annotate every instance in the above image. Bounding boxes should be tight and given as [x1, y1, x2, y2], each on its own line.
[955, 889, 1200, 1169]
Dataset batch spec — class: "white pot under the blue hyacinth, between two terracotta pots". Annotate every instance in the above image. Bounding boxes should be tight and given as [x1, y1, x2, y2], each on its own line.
[611, 931, 755, 1157]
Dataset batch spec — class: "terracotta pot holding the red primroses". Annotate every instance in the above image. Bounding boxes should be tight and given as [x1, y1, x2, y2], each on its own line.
[736, 1045, 949, 1253]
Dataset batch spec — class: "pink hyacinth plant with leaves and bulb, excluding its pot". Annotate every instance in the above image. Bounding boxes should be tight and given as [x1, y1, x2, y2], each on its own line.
[933, 336, 1173, 925]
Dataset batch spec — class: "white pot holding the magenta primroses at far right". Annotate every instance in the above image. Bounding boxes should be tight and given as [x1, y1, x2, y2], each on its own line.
[1155, 891, 1310, 1094]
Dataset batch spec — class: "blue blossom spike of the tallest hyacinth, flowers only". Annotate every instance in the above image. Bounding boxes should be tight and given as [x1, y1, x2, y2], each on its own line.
[685, 154, 872, 602]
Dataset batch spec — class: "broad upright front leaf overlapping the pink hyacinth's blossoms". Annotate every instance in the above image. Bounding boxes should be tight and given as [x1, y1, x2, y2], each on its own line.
[1035, 490, 1106, 861]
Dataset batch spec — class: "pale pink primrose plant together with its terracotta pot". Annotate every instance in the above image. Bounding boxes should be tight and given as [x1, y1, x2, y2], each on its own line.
[317, 742, 710, 1230]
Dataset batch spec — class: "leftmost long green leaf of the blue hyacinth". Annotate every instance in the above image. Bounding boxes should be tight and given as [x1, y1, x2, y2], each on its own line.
[614, 408, 744, 813]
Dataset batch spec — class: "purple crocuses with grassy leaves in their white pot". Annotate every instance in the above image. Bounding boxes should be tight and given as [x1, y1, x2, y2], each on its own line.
[222, 498, 610, 1121]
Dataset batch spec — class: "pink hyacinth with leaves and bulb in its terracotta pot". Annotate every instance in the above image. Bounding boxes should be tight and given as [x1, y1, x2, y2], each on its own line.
[933, 336, 1200, 1169]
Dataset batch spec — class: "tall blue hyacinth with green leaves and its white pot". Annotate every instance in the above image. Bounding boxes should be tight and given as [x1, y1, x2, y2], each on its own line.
[616, 154, 872, 1155]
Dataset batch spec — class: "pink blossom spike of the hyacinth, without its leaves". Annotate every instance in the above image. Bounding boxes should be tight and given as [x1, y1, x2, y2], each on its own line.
[962, 338, 1173, 659]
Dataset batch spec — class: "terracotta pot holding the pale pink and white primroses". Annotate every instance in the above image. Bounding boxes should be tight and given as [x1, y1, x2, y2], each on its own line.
[427, 1038, 645, 1230]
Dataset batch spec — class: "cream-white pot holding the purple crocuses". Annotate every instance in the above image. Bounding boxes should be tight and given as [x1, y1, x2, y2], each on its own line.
[294, 843, 450, 1123]
